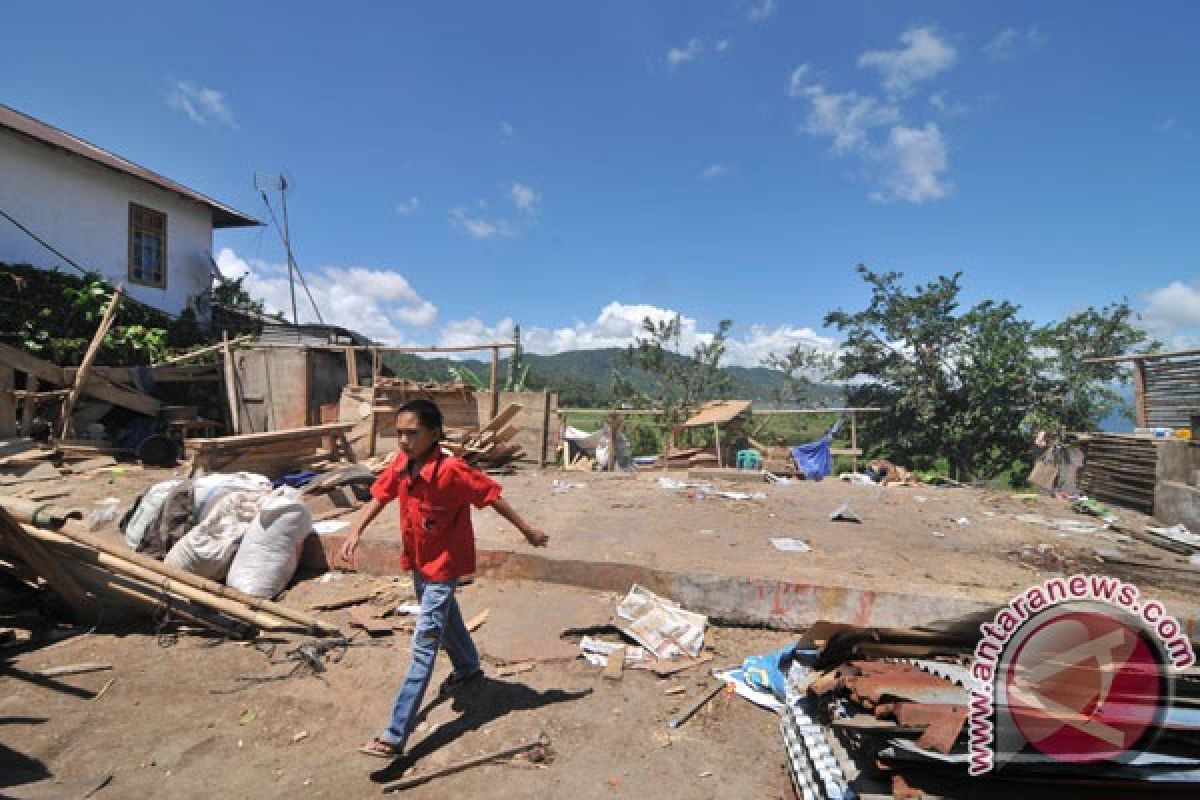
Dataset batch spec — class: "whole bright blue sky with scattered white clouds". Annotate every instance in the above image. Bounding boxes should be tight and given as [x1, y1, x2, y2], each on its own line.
[0, 0, 1200, 365]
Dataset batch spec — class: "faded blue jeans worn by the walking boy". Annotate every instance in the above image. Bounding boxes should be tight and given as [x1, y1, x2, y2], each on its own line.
[380, 571, 479, 750]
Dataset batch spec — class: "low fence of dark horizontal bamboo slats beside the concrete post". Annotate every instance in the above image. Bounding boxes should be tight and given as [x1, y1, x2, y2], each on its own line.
[1079, 433, 1158, 513]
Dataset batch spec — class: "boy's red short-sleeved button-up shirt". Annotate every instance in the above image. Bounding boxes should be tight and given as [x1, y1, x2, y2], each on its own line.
[371, 450, 500, 581]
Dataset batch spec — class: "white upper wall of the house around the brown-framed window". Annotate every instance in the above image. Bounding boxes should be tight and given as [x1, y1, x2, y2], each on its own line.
[0, 130, 212, 314]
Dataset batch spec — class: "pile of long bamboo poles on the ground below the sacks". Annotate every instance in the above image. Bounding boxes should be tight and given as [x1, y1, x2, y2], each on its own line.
[0, 505, 341, 638]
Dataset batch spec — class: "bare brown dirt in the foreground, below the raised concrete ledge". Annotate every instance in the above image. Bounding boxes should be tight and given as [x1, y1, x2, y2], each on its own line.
[0, 576, 790, 799]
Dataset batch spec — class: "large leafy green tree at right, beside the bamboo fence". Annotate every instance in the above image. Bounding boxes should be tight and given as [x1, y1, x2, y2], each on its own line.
[826, 265, 1146, 477]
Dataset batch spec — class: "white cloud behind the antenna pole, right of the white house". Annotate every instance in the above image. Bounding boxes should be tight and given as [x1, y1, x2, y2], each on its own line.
[216, 247, 438, 344]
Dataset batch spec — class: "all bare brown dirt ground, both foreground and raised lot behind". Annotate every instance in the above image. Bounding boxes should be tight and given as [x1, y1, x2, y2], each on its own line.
[0, 467, 1198, 799]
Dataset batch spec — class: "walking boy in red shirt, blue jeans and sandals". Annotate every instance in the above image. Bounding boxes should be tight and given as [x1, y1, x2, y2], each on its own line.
[341, 399, 548, 758]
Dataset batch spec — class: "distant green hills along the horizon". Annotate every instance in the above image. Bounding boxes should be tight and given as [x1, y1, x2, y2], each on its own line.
[384, 348, 842, 407]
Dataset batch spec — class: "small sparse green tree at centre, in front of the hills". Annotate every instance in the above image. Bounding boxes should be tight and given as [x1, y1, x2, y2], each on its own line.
[613, 314, 733, 426]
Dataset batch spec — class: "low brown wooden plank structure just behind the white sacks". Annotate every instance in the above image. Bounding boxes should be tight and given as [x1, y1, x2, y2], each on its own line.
[184, 422, 356, 477]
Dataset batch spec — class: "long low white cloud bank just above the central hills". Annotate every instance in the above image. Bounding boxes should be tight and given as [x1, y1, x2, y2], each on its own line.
[438, 301, 835, 367]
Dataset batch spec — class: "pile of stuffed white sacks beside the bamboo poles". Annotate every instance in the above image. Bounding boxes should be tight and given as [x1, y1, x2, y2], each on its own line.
[121, 473, 312, 597]
